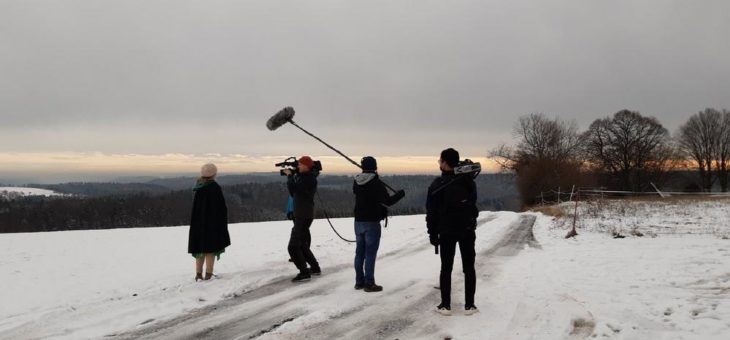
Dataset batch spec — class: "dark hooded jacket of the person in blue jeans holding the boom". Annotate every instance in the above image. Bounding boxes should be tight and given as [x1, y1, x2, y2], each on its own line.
[352, 172, 405, 222]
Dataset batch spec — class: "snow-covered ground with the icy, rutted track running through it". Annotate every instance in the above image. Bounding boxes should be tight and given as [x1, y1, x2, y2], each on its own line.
[0, 200, 730, 339]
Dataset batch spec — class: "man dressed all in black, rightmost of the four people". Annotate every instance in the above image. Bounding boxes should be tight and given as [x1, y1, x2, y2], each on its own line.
[426, 148, 479, 315]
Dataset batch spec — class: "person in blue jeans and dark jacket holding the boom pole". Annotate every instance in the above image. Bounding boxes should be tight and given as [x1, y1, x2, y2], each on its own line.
[352, 156, 405, 292]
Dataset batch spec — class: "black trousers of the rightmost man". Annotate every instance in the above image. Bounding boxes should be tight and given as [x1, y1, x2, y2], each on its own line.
[439, 230, 477, 307]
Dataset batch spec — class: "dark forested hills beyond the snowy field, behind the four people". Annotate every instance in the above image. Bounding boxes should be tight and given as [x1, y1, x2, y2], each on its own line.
[0, 174, 519, 233]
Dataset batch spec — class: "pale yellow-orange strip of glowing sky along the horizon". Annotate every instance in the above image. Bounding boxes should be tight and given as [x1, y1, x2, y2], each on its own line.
[0, 152, 498, 181]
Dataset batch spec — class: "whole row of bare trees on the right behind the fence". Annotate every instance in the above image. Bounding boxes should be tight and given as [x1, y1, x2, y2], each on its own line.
[491, 109, 730, 205]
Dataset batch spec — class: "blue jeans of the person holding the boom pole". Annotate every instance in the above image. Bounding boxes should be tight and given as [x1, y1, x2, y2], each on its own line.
[355, 221, 380, 284]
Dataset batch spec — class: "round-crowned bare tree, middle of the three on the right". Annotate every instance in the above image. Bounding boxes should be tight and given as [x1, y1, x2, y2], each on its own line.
[583, 110, 673, 191]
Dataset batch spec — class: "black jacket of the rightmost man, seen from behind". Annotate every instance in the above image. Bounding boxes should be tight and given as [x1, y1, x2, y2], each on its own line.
[426, 171, 479, 235]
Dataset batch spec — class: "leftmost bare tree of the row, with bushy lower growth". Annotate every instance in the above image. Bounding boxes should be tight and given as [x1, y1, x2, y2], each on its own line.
[490, 113, 581, 205]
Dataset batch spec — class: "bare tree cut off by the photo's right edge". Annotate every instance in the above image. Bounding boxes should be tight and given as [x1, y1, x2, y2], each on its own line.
[677, 109, 730, 192]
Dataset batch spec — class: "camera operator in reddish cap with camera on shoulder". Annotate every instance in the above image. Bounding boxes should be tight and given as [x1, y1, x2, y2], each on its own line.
[283, 156, 322, 282]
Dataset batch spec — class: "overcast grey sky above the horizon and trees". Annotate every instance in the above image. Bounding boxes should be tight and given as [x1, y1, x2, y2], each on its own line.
[0, 0, 730, 181]
